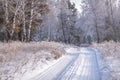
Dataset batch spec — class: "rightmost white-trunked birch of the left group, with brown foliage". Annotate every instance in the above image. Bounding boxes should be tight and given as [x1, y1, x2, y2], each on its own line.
[27, 0, 49, 41]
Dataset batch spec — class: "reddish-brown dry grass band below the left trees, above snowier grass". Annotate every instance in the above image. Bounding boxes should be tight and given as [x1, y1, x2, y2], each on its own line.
[0, 41, 65, 62]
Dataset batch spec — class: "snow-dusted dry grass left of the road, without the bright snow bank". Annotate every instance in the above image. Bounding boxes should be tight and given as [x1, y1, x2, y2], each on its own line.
[0, 41, 67, 80]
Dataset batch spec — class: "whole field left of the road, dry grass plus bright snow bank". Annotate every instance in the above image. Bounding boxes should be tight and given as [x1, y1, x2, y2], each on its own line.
[0, 41, 68, 80]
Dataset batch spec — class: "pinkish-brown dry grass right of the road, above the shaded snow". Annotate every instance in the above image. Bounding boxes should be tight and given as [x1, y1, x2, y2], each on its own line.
[92, 41, 120, 59]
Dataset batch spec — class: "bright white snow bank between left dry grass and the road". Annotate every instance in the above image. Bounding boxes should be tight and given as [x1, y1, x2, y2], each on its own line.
[15, 57, 62, 80]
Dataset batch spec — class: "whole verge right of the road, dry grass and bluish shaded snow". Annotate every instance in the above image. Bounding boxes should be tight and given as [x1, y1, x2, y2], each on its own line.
[92, 41, 120, 80]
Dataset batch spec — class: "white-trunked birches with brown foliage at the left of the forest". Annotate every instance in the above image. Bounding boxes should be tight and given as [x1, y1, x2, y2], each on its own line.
[0, 0, 49, 41]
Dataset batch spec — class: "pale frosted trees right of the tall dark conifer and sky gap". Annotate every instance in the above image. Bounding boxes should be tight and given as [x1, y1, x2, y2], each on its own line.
[78, 0, 120, 42]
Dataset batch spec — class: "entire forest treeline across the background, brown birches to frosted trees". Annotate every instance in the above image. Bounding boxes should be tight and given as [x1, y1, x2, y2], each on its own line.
[0, 0, 120, 44]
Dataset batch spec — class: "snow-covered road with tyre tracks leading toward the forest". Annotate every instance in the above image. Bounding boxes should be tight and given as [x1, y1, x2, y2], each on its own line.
[31, 48, 101, 80]
